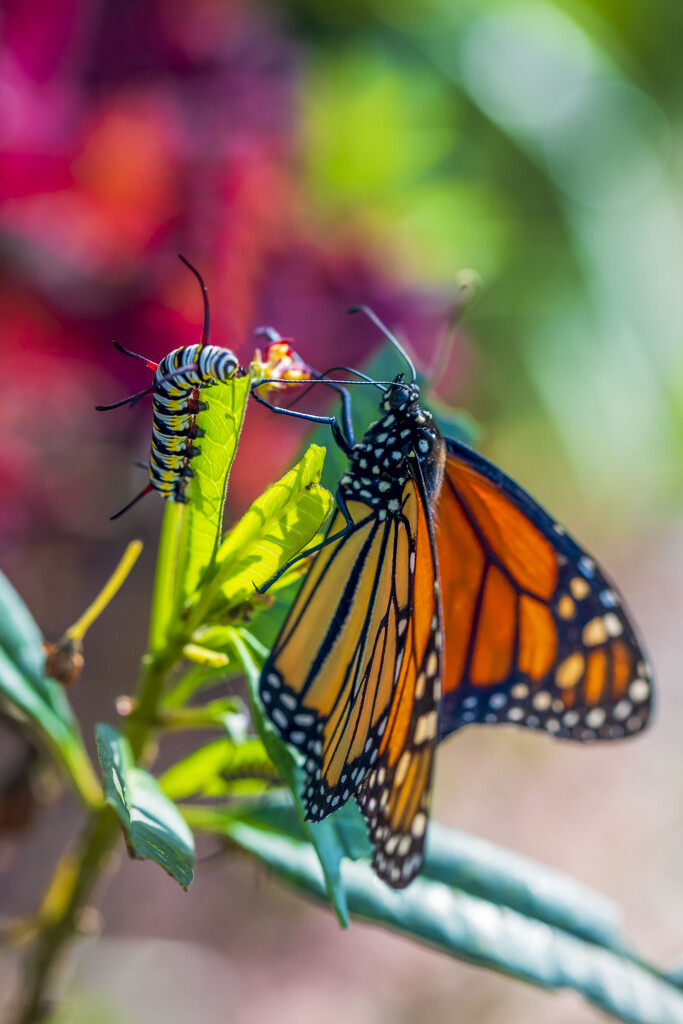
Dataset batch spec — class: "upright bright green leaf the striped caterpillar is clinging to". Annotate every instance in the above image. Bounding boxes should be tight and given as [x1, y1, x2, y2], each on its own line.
[185, 377, 251, 595]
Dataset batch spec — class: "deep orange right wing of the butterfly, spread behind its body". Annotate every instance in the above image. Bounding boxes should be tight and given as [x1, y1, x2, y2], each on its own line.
[436, 440, 651, 741]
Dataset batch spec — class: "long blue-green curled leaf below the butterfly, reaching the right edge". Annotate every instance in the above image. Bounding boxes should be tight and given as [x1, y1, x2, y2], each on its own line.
[223, 808, 683, 1024]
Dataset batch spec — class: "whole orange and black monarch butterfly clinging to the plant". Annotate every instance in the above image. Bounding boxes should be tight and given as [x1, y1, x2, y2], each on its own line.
[254, 307, 651, 889]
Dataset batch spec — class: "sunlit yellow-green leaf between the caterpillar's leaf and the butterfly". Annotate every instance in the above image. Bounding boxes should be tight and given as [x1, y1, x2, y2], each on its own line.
[211, 444, 333, 607]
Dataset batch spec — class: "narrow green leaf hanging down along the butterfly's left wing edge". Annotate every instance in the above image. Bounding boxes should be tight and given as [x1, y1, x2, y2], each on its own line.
[229, 630, 348, 928]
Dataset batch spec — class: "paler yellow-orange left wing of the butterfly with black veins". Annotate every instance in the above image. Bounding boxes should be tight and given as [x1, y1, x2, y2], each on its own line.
[260, 502, 416, 820]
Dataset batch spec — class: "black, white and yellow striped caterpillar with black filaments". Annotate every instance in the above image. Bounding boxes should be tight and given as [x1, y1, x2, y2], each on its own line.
[95, 256, 244, 519]
